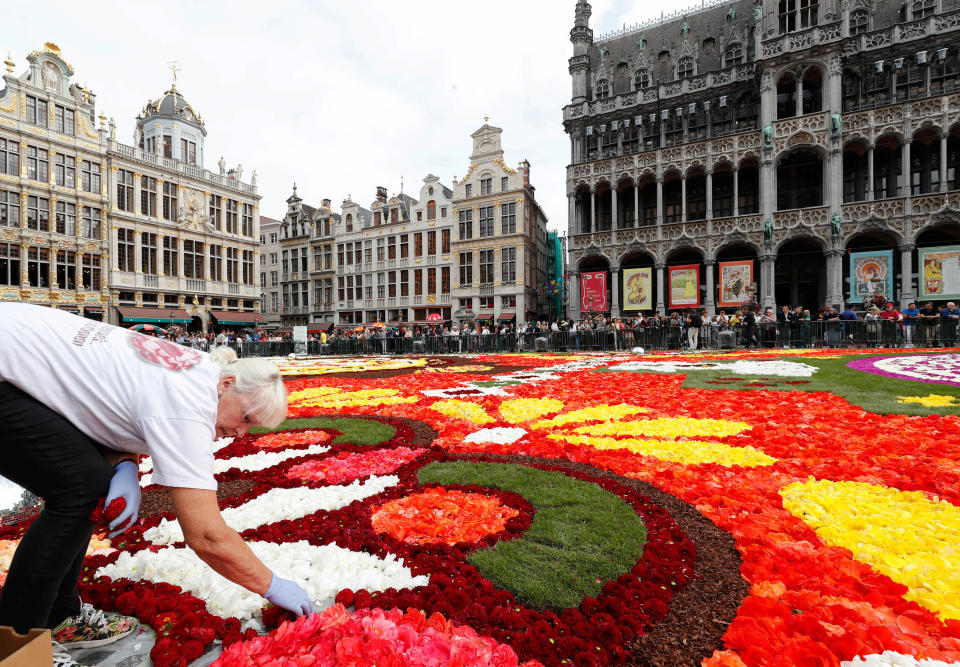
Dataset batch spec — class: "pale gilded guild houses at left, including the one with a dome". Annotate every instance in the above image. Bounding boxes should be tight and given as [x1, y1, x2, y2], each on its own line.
[0, 43, 260, 329]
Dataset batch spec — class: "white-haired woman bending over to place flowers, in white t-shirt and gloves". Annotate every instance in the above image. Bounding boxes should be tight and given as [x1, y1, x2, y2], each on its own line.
[0, 303, 313, 647]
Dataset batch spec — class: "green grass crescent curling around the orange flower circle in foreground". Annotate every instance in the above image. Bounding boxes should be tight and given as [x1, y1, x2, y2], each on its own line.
[418, 461, 647, 611]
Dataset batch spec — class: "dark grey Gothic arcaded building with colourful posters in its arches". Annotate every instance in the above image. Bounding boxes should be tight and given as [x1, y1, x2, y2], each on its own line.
[563, 0, 960, 317]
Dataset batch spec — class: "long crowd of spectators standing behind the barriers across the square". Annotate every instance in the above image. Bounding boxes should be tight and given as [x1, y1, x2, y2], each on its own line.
[144, 302, 960, 353]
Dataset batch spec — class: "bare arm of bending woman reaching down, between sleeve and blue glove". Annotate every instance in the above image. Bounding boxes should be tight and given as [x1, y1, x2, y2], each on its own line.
[167, 487, 273, 595]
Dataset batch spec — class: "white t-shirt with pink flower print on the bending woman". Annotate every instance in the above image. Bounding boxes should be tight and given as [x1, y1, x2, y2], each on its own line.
[0, 303, 220, 490]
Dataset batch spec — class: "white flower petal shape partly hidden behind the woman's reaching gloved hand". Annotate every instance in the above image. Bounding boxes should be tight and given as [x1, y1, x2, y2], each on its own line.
[97, 541, 429, 621]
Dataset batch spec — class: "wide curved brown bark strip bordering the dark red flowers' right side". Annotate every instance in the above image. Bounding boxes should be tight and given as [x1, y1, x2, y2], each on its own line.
[451, 454, 749, 667]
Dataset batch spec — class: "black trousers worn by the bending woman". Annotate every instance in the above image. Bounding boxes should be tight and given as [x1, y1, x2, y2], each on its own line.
[0, 382, 113, 633]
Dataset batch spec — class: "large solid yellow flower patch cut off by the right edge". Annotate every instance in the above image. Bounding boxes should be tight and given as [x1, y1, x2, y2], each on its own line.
[780, 478, 960, 620]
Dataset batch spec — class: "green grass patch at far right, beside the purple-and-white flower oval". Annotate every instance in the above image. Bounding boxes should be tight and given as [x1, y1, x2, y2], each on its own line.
[664, 352, 960, 415]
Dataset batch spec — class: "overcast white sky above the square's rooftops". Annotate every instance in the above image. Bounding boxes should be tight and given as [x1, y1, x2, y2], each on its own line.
[0, 0, 684, 231]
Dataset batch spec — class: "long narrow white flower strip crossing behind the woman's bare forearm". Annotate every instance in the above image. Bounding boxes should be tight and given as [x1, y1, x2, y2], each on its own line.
[143, 475, 400, 544]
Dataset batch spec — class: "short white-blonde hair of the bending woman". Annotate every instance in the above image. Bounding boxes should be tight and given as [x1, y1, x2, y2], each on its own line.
[210, 345, 287, 428]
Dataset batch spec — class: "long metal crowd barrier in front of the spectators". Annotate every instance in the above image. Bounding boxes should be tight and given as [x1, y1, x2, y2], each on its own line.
[199, 320, 960, 357]
